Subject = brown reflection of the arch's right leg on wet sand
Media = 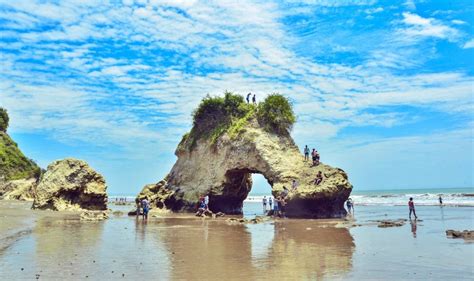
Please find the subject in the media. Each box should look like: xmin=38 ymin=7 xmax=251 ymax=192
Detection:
xmin=265 ymin=220 xmax=355 ymax=280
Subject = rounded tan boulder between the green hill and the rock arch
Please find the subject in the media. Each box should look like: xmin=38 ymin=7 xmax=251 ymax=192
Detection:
xmin=33 ymin=159 xmax=107 ymax=211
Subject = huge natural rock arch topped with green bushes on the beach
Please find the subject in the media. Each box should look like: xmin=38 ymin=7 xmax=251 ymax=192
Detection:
xmin=138 ymin=95 xmax=352 ymax=218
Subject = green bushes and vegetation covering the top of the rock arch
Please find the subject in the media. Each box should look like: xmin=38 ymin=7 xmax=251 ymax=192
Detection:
xmin=178 ymin=92 xmax=296 ymax=151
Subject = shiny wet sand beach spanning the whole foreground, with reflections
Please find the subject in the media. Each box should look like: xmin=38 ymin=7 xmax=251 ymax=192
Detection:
xmin=0 ymin=201 xmax=474 ymax=280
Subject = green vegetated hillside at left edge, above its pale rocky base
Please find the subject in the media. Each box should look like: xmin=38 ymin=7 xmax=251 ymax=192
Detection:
xmin=0 ymin=108 xmax=41 ymax=180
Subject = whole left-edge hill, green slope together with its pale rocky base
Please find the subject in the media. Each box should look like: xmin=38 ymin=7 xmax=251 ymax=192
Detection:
xmin=0 ymin=107 xmax=41 ymax=200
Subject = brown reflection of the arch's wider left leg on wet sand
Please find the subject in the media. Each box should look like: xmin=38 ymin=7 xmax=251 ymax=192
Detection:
xmin=159 ymin=219 xmax=253 ymax=280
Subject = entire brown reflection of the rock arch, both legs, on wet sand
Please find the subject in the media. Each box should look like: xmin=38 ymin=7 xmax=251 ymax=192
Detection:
xmin=159 ymin=220 xmax=355 ymax=280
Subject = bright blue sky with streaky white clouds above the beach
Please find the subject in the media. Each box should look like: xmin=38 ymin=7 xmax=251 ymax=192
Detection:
xmin=0 ymin=0 xmax=474 ymax=194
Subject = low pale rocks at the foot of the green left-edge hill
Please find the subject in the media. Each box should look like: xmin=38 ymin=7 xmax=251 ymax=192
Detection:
xmin=0 ymin=178 xmax=37 ymax=201
